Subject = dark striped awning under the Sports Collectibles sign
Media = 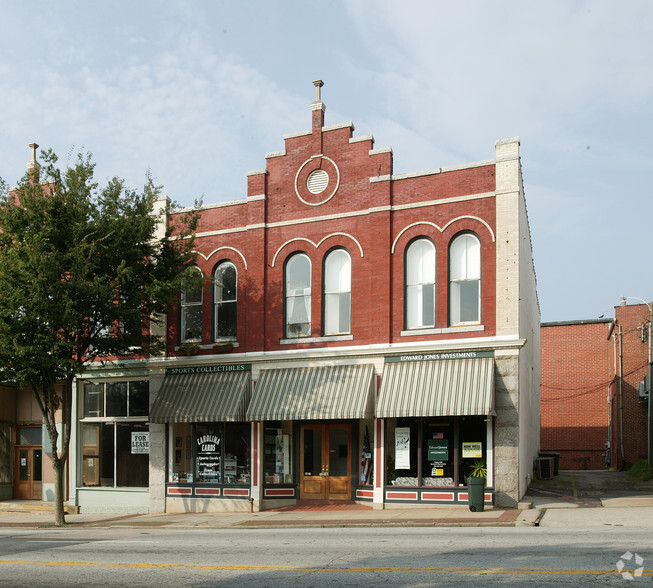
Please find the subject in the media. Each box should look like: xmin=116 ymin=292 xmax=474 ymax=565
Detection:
xmin=150 ymin=371 xmax=251 ymax=423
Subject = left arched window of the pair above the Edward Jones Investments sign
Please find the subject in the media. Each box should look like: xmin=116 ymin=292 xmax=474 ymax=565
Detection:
xmin=405 ymin=238 xmax=436 ymax=329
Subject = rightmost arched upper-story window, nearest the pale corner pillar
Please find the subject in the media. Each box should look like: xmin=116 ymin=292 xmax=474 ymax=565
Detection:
xmin=449 ymin=233 xmax=481 ymax=325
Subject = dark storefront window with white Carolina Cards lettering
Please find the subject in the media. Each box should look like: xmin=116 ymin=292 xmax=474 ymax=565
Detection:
xmin=170 ymin=423 xmax=251 ymax=484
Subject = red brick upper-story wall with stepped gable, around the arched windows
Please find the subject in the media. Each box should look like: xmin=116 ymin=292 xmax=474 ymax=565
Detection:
xmin=168 ymin=108 xmax=502 ymax=354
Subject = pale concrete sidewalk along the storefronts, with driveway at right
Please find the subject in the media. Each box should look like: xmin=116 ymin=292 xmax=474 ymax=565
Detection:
xmin=0 ymin=471 xmax=653 ymax=529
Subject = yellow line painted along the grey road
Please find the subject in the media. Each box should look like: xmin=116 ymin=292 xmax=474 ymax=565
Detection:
xmin=0 ymin=559 xmax=653 ymax=576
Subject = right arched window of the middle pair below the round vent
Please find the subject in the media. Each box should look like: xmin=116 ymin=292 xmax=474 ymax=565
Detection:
xmin=324 ymin=249 xmax=351 ymax=335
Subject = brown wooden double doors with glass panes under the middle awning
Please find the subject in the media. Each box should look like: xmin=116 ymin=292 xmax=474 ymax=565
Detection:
xmin=299 ymin=424 xmax=351 ymax=500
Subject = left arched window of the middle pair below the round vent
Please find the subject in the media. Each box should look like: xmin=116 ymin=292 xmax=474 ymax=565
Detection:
xmin=285 ymin=253 xmax=311 ymax=338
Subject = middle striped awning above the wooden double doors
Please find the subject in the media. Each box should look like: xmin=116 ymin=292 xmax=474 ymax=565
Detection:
xmin=247 ymin=364 xmax=376 ymax=421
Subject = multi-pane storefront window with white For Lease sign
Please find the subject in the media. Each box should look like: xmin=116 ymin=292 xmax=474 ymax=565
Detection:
xmin=80 ymin=380 xmax=149 ymax=488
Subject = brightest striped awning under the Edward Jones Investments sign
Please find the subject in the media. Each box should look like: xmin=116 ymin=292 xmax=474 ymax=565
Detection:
xmin=376 ymin=357 xmax=494 ymax=418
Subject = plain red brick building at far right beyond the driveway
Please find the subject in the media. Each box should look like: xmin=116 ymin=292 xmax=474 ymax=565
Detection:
xmin=541 ymin=301 xmax=650 ymax=470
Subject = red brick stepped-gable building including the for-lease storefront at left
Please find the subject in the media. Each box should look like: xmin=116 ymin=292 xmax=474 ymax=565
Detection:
xmin=61 ymin=83 xmax=540 ymax=512
